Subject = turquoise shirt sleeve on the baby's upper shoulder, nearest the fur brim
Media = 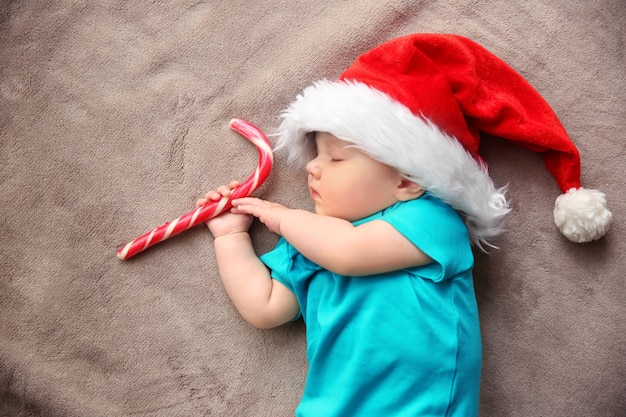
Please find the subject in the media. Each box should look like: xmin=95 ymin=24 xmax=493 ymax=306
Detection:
xmin=380 ymin=194 xmax=474 ymax=281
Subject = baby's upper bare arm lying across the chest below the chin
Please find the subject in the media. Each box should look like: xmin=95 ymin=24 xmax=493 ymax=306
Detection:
xmin=233 ymin=198 xmax=432 ymax=276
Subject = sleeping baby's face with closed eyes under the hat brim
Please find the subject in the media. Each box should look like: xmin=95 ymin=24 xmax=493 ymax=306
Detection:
xmin=306 ymin=132 xmax=404 ymax=221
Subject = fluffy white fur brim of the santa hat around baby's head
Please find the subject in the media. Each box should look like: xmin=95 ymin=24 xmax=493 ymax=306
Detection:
xmin=276 ymin=80 xmax=510 ymax=249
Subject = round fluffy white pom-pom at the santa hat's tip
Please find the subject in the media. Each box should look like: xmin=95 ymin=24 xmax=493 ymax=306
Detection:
xmin=554 ymin=188 xmax=613 ymax=243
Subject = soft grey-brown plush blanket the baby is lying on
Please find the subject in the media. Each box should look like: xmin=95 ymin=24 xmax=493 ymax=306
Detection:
xmin=0 ymin=0 xmax=626 ymax=417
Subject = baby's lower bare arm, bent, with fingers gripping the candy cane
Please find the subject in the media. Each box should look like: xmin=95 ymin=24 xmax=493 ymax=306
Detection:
xmin=198 ymin=183 xmax=299 ymax=329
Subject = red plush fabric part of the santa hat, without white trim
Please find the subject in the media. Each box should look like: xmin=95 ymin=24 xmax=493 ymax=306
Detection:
xmin=340 ymin=34 xmax=580 ymax=192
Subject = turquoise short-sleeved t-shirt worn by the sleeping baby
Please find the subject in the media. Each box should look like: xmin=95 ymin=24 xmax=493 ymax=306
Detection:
xmin=261 ymin=195 xmax=481 ymax=417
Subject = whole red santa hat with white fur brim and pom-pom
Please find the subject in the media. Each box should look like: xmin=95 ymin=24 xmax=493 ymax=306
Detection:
xmin=277 ymin=34 xmax=612 ymax=248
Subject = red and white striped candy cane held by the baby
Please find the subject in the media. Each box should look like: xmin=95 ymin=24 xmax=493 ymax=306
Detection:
xmin=117 ymin=119 xmax=274 ymax=259
